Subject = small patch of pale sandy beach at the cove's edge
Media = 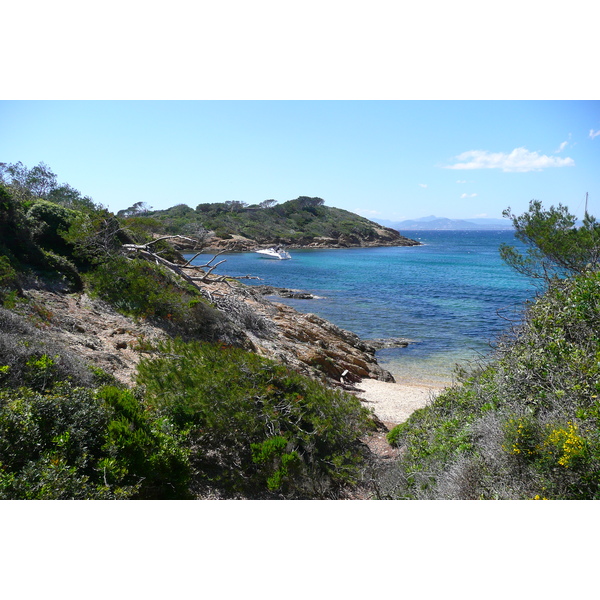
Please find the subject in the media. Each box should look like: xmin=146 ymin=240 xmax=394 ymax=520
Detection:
xmin=356 ymin=379 xmax=441 ymax=424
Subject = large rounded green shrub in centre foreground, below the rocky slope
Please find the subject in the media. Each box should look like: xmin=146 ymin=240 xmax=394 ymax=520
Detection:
xmin=138 ymin=341 xmax=372 ymax=498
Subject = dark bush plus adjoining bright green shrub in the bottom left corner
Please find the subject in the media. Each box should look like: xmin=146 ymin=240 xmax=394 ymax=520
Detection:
xmin=0 ymin=386 xmax=190 ymax=500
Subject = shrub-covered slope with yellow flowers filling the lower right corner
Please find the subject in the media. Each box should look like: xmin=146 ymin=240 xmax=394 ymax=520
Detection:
xmin=389 ymin=272 xmax=600 ymax=499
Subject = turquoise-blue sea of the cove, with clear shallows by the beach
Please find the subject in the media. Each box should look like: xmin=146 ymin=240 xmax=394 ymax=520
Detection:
xmin=186 ymin=230 xmax=536 ymax=387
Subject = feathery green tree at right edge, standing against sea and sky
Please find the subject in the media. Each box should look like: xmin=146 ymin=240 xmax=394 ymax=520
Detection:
xmin=500 ymin=200 xmax=600 ymax=283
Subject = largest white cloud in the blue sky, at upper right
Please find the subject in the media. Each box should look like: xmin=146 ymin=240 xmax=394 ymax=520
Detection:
xmin=446 ymin=148 xmax=575 ymax=173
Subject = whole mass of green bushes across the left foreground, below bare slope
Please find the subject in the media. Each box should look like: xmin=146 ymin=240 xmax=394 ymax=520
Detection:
xmin=0 ymin=309 xmax=372 ymax=499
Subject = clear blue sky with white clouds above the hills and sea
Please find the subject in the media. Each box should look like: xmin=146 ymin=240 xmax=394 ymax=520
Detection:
xmin=0 ymin=100 xmax=600 ymax=221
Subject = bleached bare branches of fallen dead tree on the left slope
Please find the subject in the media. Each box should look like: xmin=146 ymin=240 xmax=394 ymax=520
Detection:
xmin=122 ymin=235 xmax=259 ymax=286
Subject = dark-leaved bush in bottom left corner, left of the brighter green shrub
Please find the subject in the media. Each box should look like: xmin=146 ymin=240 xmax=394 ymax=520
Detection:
xmin=0 ymin=389 xmax=120 ymax=499
